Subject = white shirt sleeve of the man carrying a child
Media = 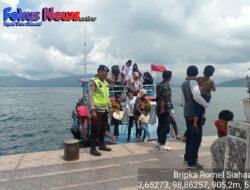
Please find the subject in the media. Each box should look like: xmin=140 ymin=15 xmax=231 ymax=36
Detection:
xmin=182 ymin=80 xmax=208 ymax=108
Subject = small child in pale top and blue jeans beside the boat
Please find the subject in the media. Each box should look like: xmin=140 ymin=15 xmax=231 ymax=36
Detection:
xmin=137 ymin=106 xmax=150 ymax=142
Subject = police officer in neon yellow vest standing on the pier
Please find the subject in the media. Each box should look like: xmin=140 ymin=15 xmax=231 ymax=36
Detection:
xmin=89 ymin=65 xmax=111 ymax=156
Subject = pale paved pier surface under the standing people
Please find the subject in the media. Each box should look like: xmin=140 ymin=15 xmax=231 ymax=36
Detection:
xmin=0 ymin=136 xmax=217 ymax=190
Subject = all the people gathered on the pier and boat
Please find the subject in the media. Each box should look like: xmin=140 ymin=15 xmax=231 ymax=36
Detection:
xmin=74 ymin=60 xmax=233 ymax=168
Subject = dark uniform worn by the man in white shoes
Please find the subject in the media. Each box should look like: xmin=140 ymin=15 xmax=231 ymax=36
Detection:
xmin=156 ymin=81 xmax=173 ymax=145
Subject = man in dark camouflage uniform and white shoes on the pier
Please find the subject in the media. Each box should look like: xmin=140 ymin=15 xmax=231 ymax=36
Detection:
xmin=156 ymin=71 xmax=174 ymax=150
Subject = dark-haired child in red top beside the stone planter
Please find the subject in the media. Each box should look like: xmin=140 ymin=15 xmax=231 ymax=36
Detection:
xmin=214 ymin=110 xmax=234 ymax=138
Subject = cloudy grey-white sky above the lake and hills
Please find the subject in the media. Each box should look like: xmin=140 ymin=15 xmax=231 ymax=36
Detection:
xmin=0 ymin=0 xmax=250 ymax=81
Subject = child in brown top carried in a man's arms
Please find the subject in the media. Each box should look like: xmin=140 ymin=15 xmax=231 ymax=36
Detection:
xmin=194 ymin=65 xmax=215 ymax=128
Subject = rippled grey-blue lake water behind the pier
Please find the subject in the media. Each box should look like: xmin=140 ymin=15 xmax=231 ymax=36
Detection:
xmin=0 ymin=87 xmax=247 ymax=155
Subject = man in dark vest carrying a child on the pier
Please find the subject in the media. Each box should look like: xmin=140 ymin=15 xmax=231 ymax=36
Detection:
xmin=181 ymin=65 xmax=208 ymax=169
